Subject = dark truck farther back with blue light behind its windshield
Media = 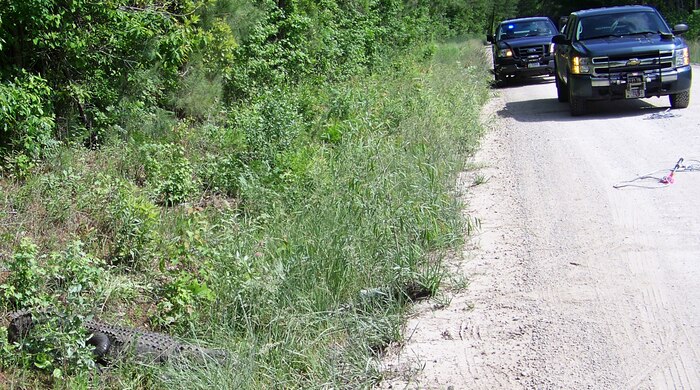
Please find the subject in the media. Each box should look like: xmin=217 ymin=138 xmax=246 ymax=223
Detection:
xmin=486 ymin=17 xmax=558 ymax=83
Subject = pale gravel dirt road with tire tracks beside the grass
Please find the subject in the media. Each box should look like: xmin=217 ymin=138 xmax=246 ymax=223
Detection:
xmin=382 ymin=67 xmax=700 ymax=389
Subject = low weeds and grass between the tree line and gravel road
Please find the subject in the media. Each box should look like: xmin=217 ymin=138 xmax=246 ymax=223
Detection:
xmin=0 ymin=41 xmax=488 ymax=388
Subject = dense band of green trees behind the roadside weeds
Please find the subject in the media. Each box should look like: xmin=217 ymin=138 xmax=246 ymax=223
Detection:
xmin=0 ymin=0 xmax=501 ymax=165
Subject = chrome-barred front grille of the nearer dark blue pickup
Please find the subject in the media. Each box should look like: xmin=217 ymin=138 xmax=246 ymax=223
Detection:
xmin=592 ymin=51 xmax=673 ymax=75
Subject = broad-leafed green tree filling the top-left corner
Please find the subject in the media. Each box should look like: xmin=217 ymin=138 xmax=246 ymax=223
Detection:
xmin=0 ymin=0 xmax=202 ymax=150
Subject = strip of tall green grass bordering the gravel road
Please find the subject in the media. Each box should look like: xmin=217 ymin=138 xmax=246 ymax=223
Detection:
xmin=169 ymin=41 xmax=487 ymax=388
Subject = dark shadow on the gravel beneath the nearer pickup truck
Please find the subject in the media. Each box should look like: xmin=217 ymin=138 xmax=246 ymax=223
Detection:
xmin=497 ymin=93 xmax=668 ymax=122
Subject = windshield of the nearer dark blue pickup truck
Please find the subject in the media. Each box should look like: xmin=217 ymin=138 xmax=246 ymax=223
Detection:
xmin=576 ymin=11 xmax=670 ymax=40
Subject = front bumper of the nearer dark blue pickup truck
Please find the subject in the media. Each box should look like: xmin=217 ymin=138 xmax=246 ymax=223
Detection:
xmin=569 ymin=66 xmax=692 ymax=100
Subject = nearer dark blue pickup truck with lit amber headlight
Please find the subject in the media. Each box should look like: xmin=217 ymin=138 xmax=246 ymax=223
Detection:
xmin=552 ymin=6 xmax=692 ymax=115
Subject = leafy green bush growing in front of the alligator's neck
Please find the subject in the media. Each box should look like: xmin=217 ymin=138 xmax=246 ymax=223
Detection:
xmin=0 ymin=240 xmax=104 ymax=378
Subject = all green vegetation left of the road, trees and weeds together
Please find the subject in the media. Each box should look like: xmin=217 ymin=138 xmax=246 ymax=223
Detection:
xmin=0 ymin=0 xmax=489 ymax=389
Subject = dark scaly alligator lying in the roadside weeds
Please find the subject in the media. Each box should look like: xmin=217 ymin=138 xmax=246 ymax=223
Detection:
xmin=7 ymin=310 xmax=228 ymax=362
